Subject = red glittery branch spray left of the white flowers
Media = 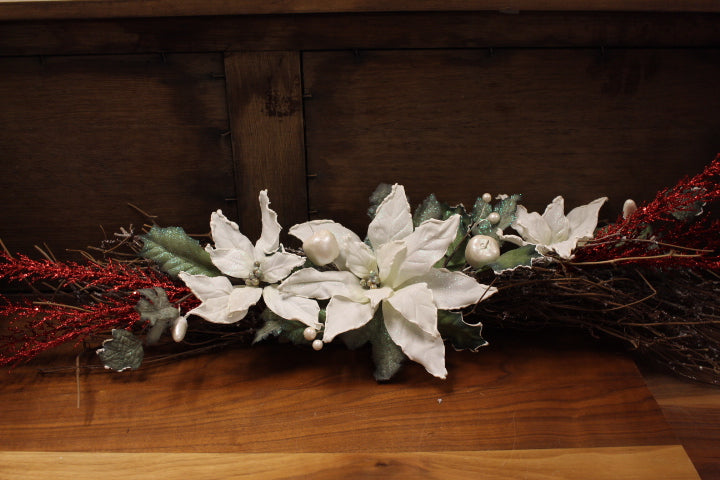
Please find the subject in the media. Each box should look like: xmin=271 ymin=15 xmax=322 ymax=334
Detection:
xmin=0 ymin=254 xmax=197 ymax=365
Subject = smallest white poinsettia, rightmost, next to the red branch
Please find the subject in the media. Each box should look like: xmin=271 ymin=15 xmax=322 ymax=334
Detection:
xmin=502 ymin=196 xmax=607 ymax=259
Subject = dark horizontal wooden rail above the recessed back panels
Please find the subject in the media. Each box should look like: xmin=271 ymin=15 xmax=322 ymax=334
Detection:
xmin=0 ymin=12 xmax=720 ymax=55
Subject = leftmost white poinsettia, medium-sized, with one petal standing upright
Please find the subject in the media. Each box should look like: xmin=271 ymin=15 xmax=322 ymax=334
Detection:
xmin=180 ymin=190 xmax=320 ymax=329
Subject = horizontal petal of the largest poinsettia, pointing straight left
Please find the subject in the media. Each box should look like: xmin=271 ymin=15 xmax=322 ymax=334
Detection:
xmin=278 ymin=268 xmax=365 ymax=300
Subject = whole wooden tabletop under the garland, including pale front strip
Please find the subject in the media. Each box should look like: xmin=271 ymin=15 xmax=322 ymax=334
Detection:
xmin=0 ymin=336 xmax=718 ymax=479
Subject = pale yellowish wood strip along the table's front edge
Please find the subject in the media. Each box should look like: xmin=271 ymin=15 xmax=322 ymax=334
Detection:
xmin=0 ymin=445 xmax=699 ymax=480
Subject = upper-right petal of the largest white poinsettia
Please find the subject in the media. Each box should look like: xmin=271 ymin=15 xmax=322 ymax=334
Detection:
xmin=391 ymin=215 xmax=460 ymax=287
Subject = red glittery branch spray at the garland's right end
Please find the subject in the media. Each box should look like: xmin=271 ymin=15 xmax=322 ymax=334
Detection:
xmin=574 ymin=155 xmax=720 ymax=271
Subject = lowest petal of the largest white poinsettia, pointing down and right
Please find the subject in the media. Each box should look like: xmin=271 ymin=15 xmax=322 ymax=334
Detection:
xmin=382 ymin=302 xmax=447 ymax=378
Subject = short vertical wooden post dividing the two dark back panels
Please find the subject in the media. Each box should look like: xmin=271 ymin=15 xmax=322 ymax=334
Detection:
xmin=225 ymin=52 xmax=307 ymax=244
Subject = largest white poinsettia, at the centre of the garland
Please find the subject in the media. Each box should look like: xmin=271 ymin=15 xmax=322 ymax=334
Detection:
xmin=279 ymin=185 xmax=497 ymax=378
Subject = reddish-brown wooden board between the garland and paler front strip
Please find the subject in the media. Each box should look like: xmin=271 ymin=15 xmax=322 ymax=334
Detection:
xmin=0 ymin=335 xmax=675 ymax=454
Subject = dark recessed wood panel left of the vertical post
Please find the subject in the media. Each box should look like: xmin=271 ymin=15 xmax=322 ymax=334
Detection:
xmin=0 ymin=54 xmax=236 ymax=256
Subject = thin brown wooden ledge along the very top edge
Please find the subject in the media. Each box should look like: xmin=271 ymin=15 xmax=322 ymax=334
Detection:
xmin=0 ymin=0 xmax=720 ymax=20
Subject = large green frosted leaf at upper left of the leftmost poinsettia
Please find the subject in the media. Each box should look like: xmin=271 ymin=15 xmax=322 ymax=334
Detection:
xmin=140 ymin=226 xmax=222 ymax=278
